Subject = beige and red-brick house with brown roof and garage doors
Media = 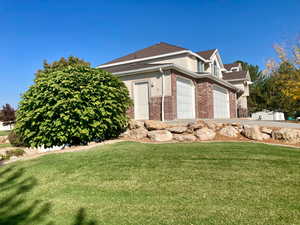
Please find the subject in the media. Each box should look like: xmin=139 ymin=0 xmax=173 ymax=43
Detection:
xmin=98 ymin=42 xmax=249 ymax=121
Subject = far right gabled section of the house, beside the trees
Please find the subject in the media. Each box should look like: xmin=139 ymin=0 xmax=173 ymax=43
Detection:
xmin=222 ymin=63 xmax=252 ymax=117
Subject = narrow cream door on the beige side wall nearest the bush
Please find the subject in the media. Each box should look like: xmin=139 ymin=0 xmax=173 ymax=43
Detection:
xmin=134 ymin=82 xmax=149 ymax=120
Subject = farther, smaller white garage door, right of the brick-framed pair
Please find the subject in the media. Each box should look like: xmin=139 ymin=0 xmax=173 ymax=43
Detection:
xmin=213 ymin=86 xmax=229 ymax=119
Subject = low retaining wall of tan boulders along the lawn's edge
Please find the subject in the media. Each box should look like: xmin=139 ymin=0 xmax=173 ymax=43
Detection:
xmin=121 ymin=120 xmax=300 ymax=144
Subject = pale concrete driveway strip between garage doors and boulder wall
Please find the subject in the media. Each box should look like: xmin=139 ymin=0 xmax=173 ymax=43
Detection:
xmin=168 ymin=119 xmax=300 ymax=129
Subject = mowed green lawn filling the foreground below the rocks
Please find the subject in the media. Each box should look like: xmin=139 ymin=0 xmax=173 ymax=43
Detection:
xmin=0 ymin=142 xmax=300 ymax=225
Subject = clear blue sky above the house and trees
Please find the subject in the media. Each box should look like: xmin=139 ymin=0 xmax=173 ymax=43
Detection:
xmin=0 ymin=0 xmax=300 ymax=106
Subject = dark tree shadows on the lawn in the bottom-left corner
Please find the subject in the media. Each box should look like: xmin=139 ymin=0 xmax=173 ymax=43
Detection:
xmin=0 ymin=167 xmax=97 ymax=225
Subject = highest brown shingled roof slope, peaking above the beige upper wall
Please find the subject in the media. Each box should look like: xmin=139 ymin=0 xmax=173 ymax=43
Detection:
xmin=102 ymin=42 xmax=187 ymax=65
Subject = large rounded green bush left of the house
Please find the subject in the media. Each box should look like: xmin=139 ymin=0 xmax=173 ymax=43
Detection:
xmin=14 ymin=57 xmax=131 ymax=147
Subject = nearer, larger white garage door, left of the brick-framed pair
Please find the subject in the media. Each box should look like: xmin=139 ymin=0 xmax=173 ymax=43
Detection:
xmin=176 ymin=78 xmax=195 ymax=119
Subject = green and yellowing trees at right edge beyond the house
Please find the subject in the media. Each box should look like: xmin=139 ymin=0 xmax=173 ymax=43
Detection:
xmin=239 ymin=40 xmax=300 ymax=116
